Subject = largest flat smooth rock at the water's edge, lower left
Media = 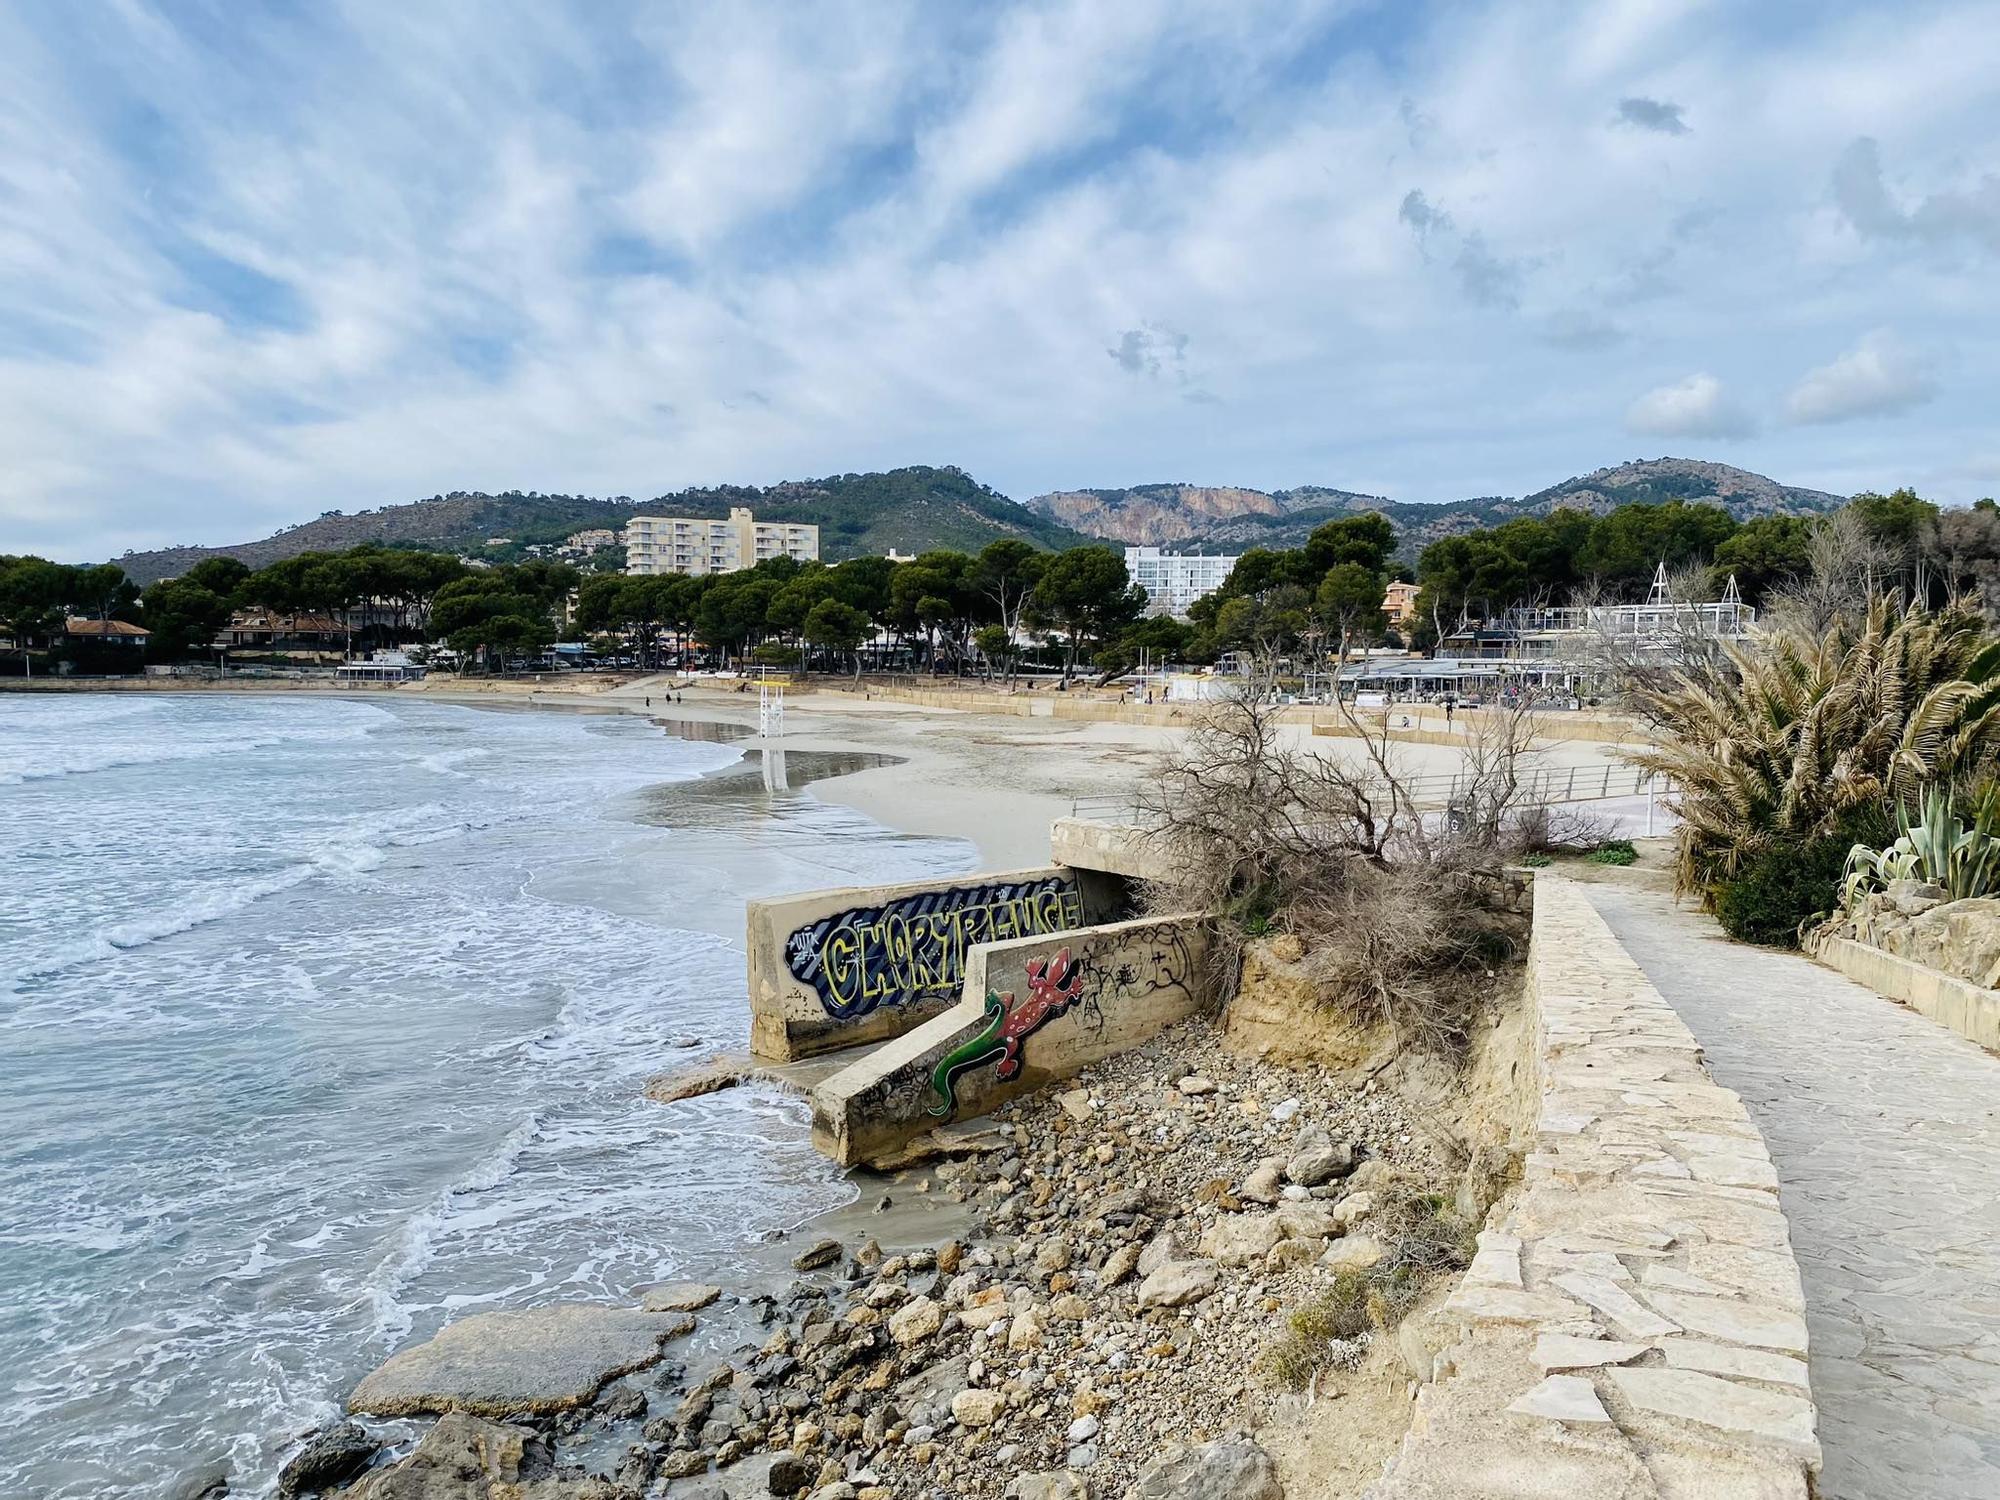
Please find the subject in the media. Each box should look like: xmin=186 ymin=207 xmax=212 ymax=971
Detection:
xmin=348 ymin=1306 xmax=694 ymax=1416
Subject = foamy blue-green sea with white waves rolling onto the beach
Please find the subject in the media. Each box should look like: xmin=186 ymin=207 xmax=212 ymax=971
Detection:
xmin=0 ymin=694 xmax=972 ymax=1498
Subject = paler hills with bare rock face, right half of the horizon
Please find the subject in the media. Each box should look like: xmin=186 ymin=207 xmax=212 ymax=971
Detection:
xmin=1028 ymin=458 xmax=1844 ymax=558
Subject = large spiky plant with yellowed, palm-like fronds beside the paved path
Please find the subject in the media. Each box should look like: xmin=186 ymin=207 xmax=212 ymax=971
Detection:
xmin=1632 ymin=596 xmax=2000 ymax=904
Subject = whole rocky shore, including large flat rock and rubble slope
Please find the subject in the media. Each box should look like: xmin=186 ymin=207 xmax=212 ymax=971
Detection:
xmin=300 ymin=1020 xmax=1484 ymax=1500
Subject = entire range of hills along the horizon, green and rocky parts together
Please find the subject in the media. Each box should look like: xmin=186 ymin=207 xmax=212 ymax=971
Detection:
xmin=118 ymin=458 xmax=1846 ymax=584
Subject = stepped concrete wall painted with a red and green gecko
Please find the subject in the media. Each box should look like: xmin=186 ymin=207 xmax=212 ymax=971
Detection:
xmin=812 ymin=916 xmax=1210 ymax=1166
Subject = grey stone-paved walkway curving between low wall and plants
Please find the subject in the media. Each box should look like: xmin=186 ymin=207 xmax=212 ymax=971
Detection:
xmin=1584 ymin=884 xmax=2000 ymax=1500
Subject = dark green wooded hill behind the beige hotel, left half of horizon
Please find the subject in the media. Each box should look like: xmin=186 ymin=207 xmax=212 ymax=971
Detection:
xmin=118 ymin=468 xmax=1088 ymax=584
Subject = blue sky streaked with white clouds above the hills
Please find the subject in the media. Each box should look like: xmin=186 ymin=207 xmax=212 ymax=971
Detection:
xmin=0 ymin=0 xmax=2000 ymax=560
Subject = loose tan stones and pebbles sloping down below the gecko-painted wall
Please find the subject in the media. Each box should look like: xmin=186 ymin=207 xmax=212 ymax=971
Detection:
xmin=532 ymin=1022 xmax=1430 ymax=1500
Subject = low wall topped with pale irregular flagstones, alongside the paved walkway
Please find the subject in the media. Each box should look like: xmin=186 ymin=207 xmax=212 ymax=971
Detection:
xmin=1368 ymin=878 xmax=1820 ymax=1500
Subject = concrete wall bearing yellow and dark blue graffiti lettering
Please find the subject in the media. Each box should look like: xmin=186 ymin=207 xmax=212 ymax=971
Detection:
xmin=746 ymin=866 xmax=1124 ymax=1062
